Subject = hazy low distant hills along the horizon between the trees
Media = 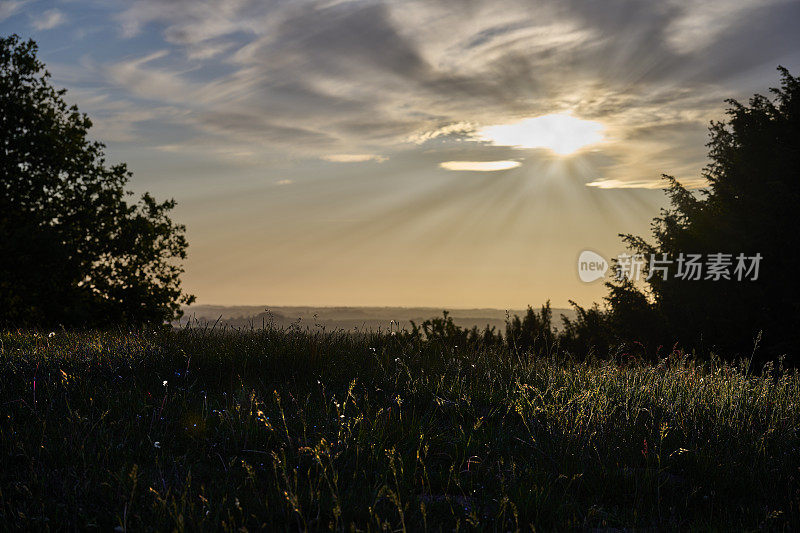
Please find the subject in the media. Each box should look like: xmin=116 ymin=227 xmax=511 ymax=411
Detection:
xmin=179 ymin=305 xmax=575 ymax=332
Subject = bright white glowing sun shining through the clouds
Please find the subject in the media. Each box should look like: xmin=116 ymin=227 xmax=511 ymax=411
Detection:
xmin=477 ymin=113 xmax=605 ymax=155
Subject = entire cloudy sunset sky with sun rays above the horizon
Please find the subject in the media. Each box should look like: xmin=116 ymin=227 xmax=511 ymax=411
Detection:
xmin=0 ymin=0 xmax=800 ymax=309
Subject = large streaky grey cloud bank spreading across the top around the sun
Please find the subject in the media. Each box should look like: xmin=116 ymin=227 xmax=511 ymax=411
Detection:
xmin=72 ymin=0 xmax=800 ymax=182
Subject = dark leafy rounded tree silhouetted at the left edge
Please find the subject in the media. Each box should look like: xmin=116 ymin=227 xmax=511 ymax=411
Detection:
xmin=0 ymin=35 xmax=194 ymax=326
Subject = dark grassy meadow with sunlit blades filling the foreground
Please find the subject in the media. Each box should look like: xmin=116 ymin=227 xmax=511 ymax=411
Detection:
xmin=0 ymin=330 xmax=800 ymax=531
